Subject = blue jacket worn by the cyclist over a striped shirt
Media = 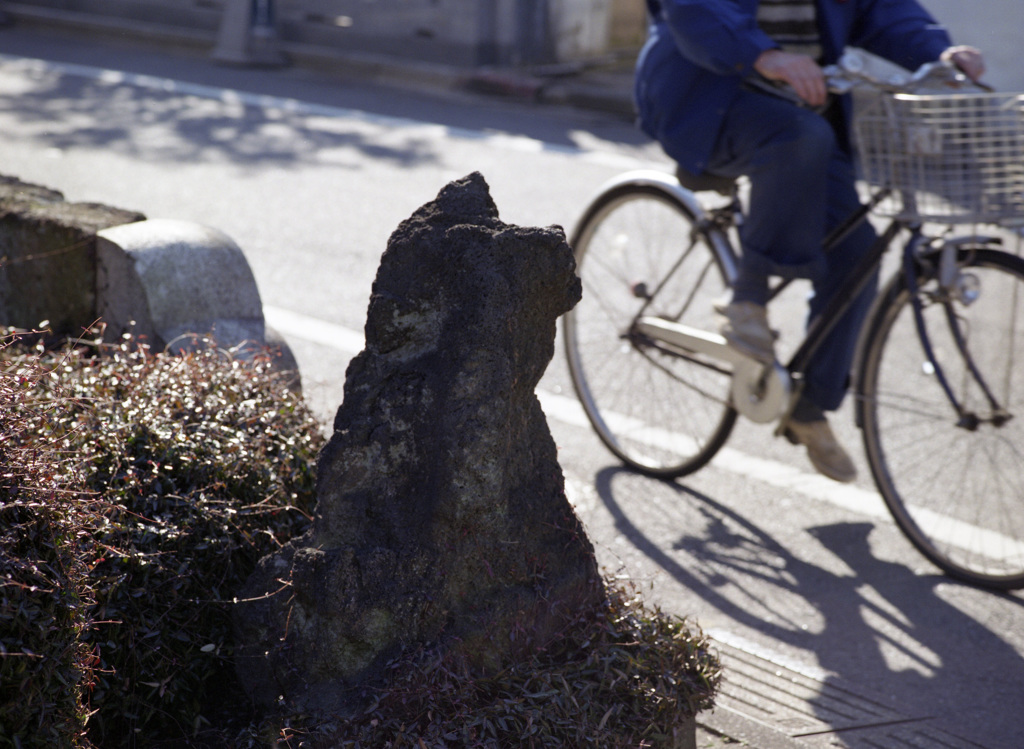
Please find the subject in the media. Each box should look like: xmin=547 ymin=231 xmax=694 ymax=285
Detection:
xmin=636 ymin=0 xmax=951 ymax=173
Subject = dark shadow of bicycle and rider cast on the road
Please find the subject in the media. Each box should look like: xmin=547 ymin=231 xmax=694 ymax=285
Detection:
xmin=595 ymin=467 xmax=1024 ymax=749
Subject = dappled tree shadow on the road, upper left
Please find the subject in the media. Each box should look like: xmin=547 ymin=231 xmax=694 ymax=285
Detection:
xmin=0 ymin=65 xmax=438 ymax=169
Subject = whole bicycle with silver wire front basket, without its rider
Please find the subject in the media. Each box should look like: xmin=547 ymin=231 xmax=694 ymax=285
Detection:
xmin=563 ymin=54 xmax=1024 ymax=589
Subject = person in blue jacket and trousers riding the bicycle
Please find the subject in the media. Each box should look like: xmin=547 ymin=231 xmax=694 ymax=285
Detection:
xmin=636 ymin=0 xmax=984 ymax=482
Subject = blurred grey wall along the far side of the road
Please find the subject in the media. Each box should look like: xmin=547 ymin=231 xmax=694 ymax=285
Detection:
xmin=0 ymin=0 xmax=1024 ymax=86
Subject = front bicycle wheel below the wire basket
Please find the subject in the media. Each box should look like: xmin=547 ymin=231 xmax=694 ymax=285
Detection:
xmin=858 ymin=249 xmax=1024 ymax=589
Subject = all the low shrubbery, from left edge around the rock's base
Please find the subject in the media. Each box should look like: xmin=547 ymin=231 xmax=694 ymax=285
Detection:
xmin=0 ymin=331 xmax=719 ymax=749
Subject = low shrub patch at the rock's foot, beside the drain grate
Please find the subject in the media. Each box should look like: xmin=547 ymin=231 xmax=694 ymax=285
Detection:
xmin=264 ymin=581 xmax=720 ymax=749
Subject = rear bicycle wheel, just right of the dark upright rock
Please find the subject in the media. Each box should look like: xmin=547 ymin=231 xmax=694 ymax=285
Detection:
xmin=563 ymin=178 xmax=736 ymax=477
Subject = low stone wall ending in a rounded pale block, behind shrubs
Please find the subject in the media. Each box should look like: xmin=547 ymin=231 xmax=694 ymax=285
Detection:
xmin=0 ymin=175 xmax=300 ymax=390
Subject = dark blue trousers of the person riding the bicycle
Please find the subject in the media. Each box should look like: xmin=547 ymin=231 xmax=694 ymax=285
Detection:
xmin=708 ymin=91 xmax=878 ymax=411
